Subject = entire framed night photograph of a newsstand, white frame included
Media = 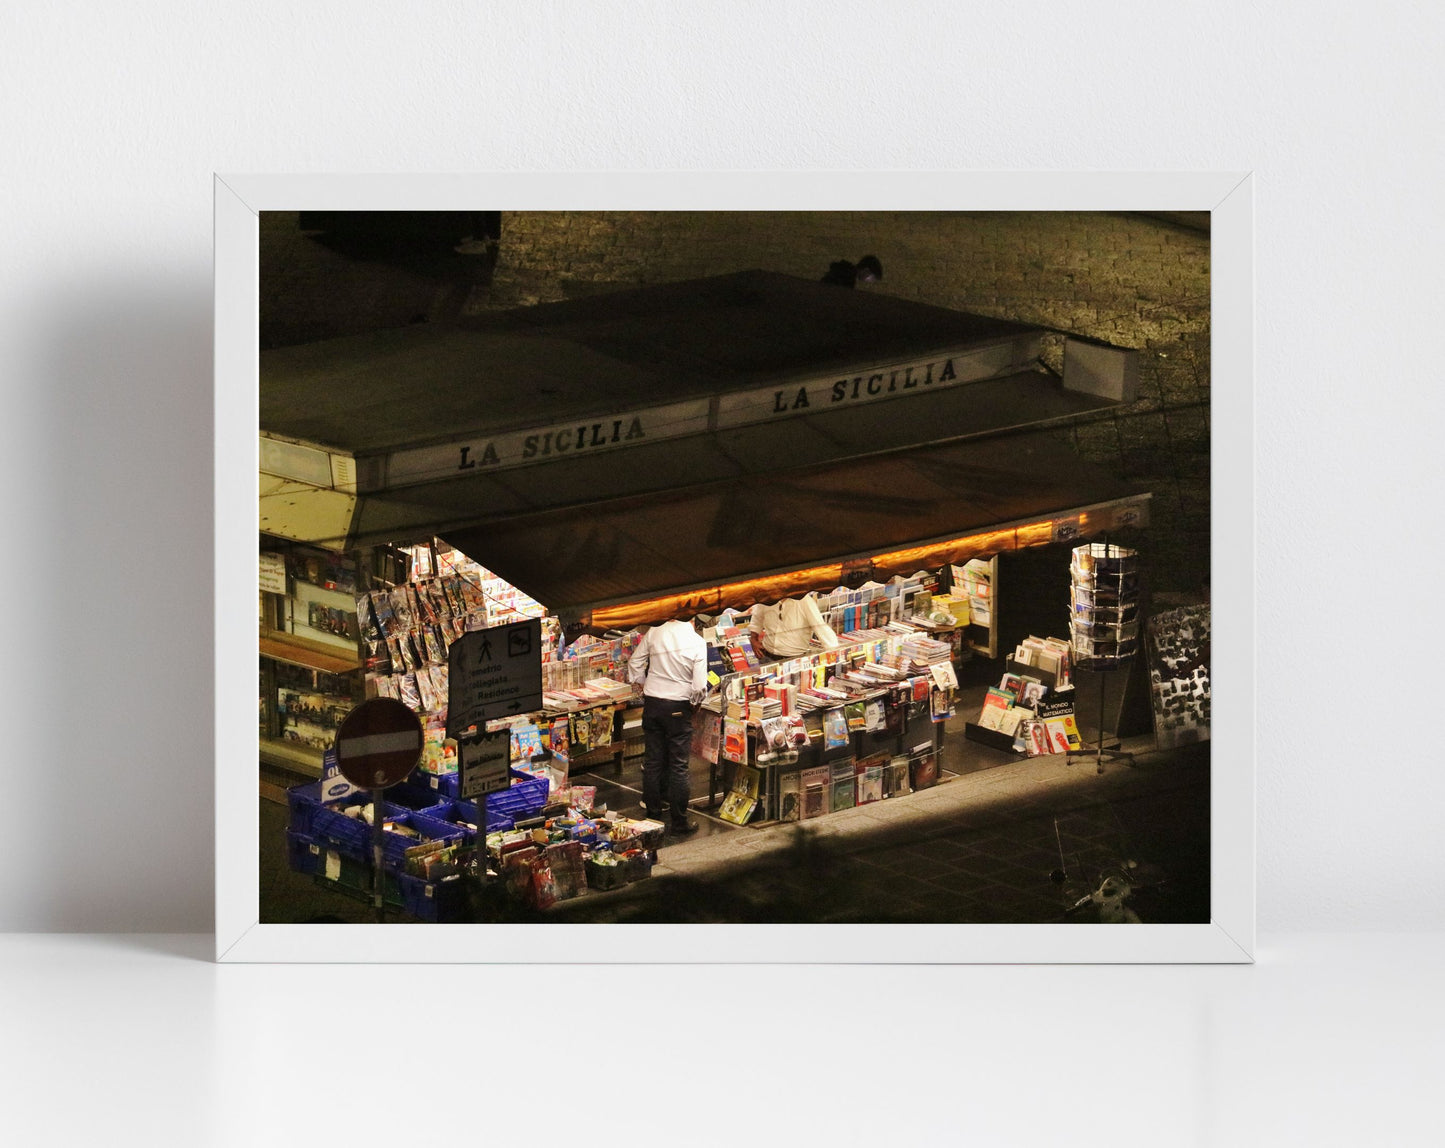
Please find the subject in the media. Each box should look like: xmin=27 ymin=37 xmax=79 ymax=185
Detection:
xmin=215 ymin=172 xmax=1254 ymax=963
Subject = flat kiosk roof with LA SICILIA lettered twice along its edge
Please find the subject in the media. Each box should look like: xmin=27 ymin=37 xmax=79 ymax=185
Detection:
xmin=259 ymin=272 xmax=1134 ymax=549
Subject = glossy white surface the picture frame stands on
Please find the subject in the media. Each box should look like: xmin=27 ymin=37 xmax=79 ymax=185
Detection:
xmin=0 ymin=934 xmax=1445 ymax=1148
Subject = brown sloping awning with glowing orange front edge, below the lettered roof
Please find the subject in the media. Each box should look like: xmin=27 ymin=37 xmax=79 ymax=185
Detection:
xmin=445 ymin=432 xmax=1149 ymax=626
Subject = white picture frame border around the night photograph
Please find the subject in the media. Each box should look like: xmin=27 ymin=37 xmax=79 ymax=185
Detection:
xmin=214 ymin=172 xmax=1256 ymax=963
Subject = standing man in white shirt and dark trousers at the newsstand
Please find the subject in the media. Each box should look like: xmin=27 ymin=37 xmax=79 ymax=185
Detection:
xmin=627 ymin=619 xmax=708 ymax=837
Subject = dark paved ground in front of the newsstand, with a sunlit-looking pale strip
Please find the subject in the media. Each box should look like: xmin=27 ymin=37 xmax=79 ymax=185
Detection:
xmin=551 ymin=737 xmax=1209 ymax=922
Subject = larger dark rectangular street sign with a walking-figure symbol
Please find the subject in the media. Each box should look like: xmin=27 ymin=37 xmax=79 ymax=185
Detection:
xmin=447 ymin=617 xmax=542 ymax=737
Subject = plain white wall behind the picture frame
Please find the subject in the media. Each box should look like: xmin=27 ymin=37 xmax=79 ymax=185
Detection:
xmin=0 ymin=0 xmax=1445 ymax=930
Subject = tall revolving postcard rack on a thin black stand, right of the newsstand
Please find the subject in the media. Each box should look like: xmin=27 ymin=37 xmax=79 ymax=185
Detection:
xmin=1069 ymin=538 xmax=1139 ymax=774
